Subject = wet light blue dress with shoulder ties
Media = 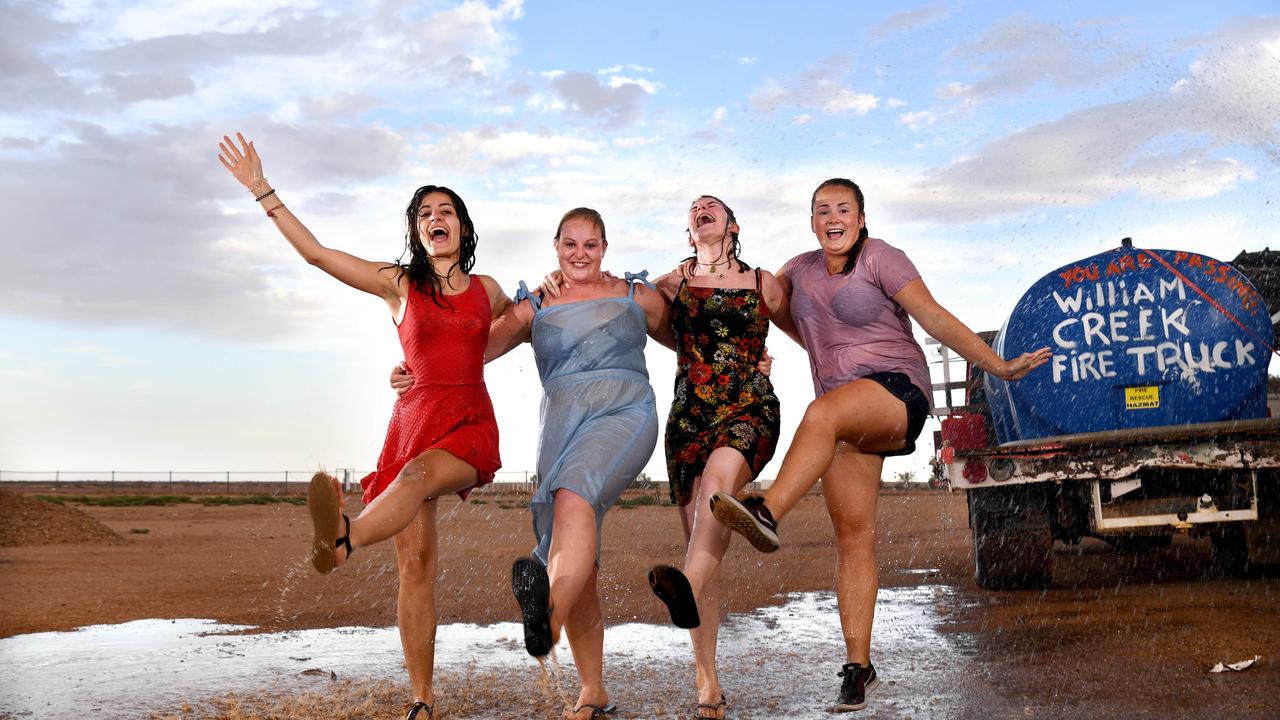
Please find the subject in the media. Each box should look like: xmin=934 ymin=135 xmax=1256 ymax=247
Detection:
xmin=516 ymin=273 xmax=658 ymax=565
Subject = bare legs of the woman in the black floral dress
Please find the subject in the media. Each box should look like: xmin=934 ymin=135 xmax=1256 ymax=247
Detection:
xmin=681 ymin=447 xmax=751 ymax=717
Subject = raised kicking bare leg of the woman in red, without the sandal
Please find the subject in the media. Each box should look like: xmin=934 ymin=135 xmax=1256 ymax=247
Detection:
xmin=339 ymin=450 xmax=476 ymax=559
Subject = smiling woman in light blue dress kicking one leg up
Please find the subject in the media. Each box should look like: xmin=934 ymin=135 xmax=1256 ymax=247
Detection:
xmin=485 ymin=208 xmax=673 ymax=720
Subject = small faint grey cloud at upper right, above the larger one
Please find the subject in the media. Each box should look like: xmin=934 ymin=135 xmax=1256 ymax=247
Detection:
xmin=938 ymin=13 xmax=1143 ymax=101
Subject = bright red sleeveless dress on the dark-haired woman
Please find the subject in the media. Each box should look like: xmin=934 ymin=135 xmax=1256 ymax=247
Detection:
xmin=360 ymin=275 xmax=502 ymax=502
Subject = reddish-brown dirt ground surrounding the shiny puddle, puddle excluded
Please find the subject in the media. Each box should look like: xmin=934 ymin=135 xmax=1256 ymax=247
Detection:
xmin=0 ymin=484 xmax=1280 ymax=720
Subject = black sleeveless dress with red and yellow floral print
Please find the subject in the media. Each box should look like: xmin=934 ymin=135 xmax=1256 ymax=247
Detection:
xmin=666 ymin=270 xmax=778 ymax=505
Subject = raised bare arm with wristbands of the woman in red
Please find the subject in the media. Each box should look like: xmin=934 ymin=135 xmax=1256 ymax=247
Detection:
xmin=218 ymin=133 xmax=401 ymax=301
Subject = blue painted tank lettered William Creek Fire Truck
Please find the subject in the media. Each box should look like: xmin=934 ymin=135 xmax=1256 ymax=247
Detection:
xmin=987 ymin=247 xmax=1276 ymax=443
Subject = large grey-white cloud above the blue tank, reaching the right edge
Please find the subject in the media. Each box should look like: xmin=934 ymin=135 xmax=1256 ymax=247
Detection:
xmin=902 ymin=22 xmax=1280 ymax=222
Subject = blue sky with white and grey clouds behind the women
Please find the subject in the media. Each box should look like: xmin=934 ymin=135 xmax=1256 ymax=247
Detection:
xmin=0 ymin=0 xmax=1280 ymax=479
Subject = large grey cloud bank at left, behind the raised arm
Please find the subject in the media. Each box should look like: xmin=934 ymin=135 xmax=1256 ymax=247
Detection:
xmin=0 ymin=122 xmax=404 ymax=340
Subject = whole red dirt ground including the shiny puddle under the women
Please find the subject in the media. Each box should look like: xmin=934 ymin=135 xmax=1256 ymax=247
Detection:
xmin=0 ymin=484 xmax=1280 ymax=720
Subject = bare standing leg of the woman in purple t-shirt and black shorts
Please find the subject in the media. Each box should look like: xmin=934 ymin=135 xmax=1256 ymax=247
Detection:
xmin=822 ymin=445 xmax=884 ymax=665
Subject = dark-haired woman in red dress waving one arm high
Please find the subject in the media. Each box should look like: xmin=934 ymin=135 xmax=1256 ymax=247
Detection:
xmin=219 ymin=135 xmax=501 ymax=720
